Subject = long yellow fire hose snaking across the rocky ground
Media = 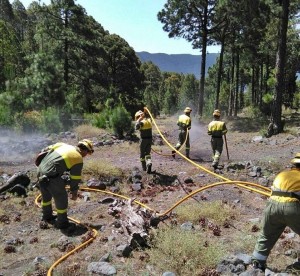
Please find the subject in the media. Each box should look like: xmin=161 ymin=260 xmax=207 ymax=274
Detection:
xmin=35 ymin=107 xmax=271 ymax=276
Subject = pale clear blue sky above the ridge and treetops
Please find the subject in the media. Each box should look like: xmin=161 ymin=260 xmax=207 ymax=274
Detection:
xmin=10 ymin=0 xmax=219 ymax=55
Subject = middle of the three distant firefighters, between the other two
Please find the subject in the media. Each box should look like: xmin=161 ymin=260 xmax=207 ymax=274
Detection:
xmin=172 ymin=107 xmax=192 ymax=158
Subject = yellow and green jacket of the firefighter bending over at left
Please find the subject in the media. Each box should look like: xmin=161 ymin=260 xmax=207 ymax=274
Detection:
xmin=38 ymin=143 xmax=83 ymax=191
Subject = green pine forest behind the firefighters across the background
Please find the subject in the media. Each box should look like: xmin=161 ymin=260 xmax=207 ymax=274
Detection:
xmin=0 ymin=0 xmax=300 ymax=134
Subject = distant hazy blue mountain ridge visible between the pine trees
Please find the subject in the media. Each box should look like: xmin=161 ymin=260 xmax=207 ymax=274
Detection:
xmin=136 ymin=52 xmax=219 ymax=79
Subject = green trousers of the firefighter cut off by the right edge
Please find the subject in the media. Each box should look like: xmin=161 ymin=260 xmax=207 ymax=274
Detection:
xmin=253 ymin=199 xmax=300 ymax=261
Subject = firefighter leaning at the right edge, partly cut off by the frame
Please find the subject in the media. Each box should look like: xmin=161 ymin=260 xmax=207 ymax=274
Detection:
xmin=252 ymin=153 xmax=300 ymax=275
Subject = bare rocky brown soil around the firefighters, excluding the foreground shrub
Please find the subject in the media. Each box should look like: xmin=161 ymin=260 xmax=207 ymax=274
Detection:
xmin=0 ymin=113 xmax=300 ymax=275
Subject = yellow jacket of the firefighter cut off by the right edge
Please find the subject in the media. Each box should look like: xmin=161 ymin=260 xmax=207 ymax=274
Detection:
xmin=270 ymin=168 xmax=300 ymax=202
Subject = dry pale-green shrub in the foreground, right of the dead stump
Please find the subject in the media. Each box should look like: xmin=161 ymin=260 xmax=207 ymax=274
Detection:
xmin=147 ymin=228 xmax=225 ymax=275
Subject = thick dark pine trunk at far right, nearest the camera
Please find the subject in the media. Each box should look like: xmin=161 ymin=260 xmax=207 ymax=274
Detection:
xmin=272 ymin=0 xmax=290 ymax=134
